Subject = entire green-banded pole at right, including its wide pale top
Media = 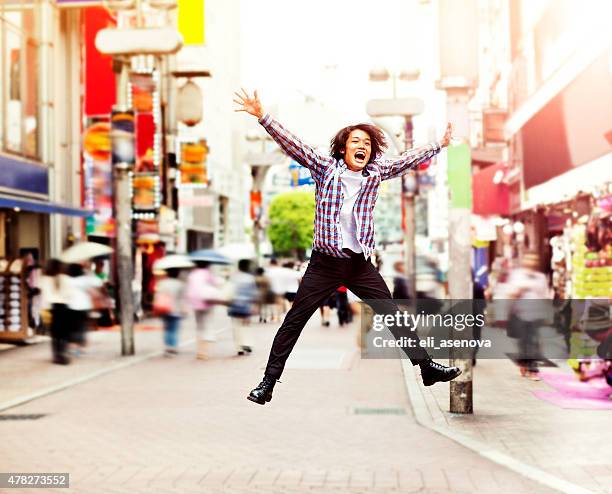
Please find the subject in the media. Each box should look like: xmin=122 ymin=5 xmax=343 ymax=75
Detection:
xmin=436 ymin=0 xmax=479 ymax=413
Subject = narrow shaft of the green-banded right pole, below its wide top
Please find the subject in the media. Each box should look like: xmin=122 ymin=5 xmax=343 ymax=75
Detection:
xmin=446 ymin=88 xmax=474 ymax=413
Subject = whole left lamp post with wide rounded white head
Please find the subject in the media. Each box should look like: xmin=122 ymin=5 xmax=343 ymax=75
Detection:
xmin=96 ymin=0 xmax=183 ymax=355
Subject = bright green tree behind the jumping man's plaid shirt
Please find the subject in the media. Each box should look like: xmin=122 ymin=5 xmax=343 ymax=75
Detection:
xmin=268 ymin=191 xmax=315 ymax=260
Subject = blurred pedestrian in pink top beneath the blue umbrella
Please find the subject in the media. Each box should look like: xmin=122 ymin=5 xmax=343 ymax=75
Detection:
xmin=187 ymin=261 xmax=222 ymax=360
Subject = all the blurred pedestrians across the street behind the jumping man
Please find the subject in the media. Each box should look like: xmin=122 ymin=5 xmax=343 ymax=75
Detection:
xmin=36 ymin=245 xmax=612 ymax=392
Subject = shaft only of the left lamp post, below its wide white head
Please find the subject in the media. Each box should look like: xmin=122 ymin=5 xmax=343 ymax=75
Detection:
xmin=114 ymin=60 xmax=134 ymax=355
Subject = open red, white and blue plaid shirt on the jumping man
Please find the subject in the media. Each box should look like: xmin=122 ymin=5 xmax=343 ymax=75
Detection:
xmin=259 ymin=114 xmax=440 ymax=258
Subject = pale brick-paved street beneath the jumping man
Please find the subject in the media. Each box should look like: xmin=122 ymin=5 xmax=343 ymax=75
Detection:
xmin=0 ymin=310 xmax=553 ymax=494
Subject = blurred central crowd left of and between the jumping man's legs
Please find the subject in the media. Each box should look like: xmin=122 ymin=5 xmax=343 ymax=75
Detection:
xmin=153 ymin=258 xmax=368 ymax=360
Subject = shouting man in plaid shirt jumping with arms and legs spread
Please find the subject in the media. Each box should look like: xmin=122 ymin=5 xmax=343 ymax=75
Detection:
xmin=234 ymin=90 xmax=461 ymax=405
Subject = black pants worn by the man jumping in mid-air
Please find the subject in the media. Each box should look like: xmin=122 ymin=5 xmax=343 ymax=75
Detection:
xmin=266 ymin=251 xmax=429 ymax=379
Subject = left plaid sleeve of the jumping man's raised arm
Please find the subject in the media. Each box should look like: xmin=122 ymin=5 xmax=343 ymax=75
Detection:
xmin=259 ymin=113 xmax=331 ymax=181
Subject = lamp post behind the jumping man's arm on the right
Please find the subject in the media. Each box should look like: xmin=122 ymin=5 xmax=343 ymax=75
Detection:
xmin=367 ymin=68 xmax=424 ymax=299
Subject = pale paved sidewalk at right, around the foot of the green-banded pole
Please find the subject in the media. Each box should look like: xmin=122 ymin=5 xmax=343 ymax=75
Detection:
xmin=405 ymin=359 xmax=612 ymax=493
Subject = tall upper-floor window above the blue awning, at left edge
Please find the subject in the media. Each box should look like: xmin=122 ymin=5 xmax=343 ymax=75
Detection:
xmin=0 ymin=0 xmax=39 ymax=159
